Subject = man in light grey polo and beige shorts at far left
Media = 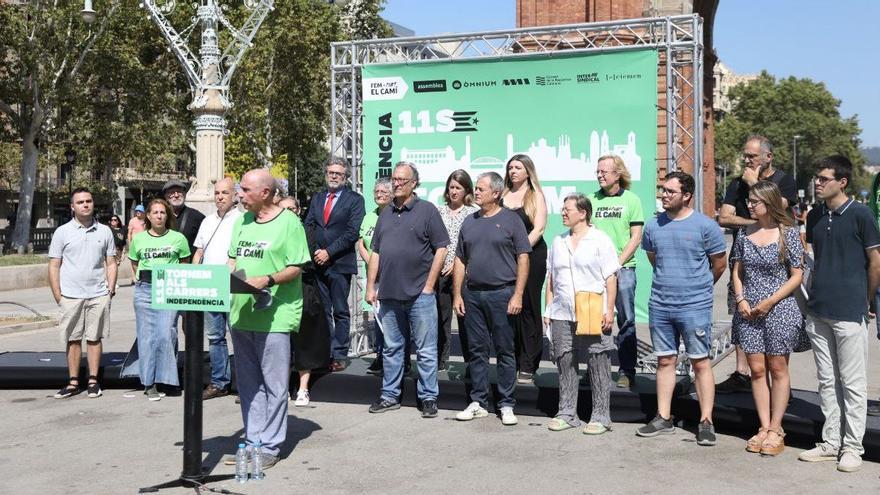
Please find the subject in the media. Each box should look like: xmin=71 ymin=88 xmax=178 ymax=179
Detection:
xmin=49 ymin=188 xmax=116 ymax=399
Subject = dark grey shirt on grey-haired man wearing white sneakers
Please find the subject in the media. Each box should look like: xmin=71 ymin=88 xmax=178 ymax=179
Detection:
xmin=455 ymin=208 xmax=532 ymax=286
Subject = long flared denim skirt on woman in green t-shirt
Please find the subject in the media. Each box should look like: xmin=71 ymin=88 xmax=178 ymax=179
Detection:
xmin=120 ymin=281 xmax=180 ymax=387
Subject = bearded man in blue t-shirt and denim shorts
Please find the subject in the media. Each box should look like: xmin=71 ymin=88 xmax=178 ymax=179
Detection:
xmin=636 ymin=172 xmax=727 ymax=446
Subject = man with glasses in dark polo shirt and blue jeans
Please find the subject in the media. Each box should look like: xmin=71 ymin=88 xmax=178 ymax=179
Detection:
xmin=364 ymin=162 xmax=449 ymax=418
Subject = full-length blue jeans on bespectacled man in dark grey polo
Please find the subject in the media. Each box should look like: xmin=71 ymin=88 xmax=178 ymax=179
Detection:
xmin=376 ymin=293 xmax=440 ymax=402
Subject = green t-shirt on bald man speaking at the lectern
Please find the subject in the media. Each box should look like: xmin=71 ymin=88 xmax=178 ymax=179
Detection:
xmin=229 ymin=210 xmax=311 ymax=333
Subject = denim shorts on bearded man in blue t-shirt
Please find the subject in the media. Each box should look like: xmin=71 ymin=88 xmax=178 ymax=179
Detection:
xmin=648 ymin=308 xmax=712 ymax=359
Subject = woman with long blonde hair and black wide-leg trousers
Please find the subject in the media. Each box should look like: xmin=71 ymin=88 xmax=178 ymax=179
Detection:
xmin=501 ymin=155 xmax=547 ymax=383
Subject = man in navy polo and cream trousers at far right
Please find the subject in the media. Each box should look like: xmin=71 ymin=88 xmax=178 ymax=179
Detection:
xmin=798 ymin=155 xmax=880 ymax=473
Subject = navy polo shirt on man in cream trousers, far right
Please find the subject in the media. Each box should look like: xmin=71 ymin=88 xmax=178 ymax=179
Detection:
xmin=807 ymin=199 xmax=880 ymax=322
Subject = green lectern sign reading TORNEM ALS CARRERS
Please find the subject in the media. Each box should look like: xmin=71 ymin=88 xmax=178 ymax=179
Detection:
xmin=152 ymin=264 xmax=229 ymax=313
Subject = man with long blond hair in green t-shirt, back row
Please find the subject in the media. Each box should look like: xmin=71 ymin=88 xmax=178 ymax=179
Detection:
xmin=589 ymin=155 xmax=645 ymax=388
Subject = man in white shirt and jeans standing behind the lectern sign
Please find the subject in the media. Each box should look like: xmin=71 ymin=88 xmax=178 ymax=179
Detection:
xmin=193 ymin=177 xmax=241 ymax=400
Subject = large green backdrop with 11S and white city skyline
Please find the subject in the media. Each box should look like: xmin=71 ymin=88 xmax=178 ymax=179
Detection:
xmin=362 ymin=50 xmax=657 ymax=321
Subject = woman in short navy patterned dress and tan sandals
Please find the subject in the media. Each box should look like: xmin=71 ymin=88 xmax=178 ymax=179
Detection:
xmin=731 ymin=180 xmax=808 ymax=456
